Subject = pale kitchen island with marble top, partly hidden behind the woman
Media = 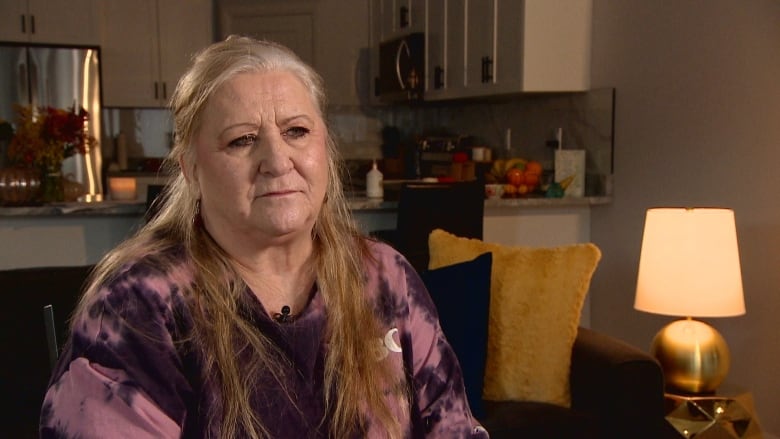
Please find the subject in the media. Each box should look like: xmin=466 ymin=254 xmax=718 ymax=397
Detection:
xmin=0 ymin=194 xmax=611 ymax=269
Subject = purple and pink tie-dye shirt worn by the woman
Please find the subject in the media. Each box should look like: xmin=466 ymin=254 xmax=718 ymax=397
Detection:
xmin=41 ymin=242 xmax=488 ymax=439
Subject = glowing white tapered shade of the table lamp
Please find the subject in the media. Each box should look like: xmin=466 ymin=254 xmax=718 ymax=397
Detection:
xmin=634 ymin=208 xmax=745 ymax=317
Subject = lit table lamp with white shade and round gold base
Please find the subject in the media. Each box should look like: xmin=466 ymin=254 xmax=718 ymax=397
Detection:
xmin=634 ymin=208 xmax=745 ymax=394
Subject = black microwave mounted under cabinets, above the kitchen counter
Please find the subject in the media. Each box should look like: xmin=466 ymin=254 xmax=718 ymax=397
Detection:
xmin=374 ymin=32 xmax=425 ymax=102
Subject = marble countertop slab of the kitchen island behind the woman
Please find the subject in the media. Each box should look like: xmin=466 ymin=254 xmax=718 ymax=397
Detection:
xmin=0 ymin=195 xmax=612 ymax=217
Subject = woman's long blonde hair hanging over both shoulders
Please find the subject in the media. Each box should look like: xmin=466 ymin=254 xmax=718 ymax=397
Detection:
xmin=81 ymin=36 xmax=408 ymax=438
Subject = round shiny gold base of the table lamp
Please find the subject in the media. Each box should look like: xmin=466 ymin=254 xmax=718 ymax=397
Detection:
xmin=651 ymin=318 xmax=731 ymax=395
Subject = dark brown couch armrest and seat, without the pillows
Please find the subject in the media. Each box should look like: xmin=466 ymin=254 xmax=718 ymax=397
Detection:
xmin=481 ymin=327 xmax=673 ymax=439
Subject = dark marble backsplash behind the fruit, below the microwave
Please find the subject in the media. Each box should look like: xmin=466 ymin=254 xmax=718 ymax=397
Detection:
xmin=377 ymin=88 xmax=615 ymax=180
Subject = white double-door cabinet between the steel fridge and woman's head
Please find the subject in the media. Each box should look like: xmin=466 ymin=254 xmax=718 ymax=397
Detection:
xmin=101 ymin=0 xmax=214 ymax=108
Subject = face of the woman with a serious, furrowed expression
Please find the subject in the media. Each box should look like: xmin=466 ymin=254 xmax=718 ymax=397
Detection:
xmin=189 ymin=71 xmax=328 ymax=251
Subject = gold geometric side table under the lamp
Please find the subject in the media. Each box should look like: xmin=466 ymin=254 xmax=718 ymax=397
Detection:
xmin=664 ymin=392 xmax=763 ymax=439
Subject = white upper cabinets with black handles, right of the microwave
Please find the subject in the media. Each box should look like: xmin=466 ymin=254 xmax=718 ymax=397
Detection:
xmin=425 ymin=0 xmax=592 ymax=100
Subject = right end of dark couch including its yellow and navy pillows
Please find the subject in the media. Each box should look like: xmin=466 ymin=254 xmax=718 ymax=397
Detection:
xmin=420 ymin=230 xmax=679 ymax=439
